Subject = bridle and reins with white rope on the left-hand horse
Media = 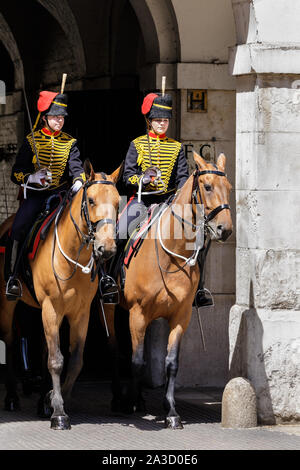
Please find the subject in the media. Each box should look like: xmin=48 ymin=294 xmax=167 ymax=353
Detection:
xmin=52 ymin=173 xmax=116 ymax=281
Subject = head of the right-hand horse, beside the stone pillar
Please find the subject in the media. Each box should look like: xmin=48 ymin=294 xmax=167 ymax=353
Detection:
xmin=194 ymin=152 xmax=232 ymax=241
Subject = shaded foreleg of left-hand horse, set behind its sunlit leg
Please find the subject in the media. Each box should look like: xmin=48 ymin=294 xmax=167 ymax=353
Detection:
xmin=62 ymin=312 xmax=89 ymax=399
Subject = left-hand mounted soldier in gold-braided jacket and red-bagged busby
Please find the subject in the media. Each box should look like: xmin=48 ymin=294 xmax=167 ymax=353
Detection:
xmin=6 ymin=91 xmax=86 ymax=300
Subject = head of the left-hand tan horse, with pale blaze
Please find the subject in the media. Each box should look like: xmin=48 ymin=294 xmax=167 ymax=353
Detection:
xmin=82 ymin=161 xmax=120 ymax=261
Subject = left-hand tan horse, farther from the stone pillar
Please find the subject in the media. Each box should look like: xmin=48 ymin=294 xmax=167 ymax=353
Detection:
xmin=0 ymin=162 xmax=120 ymax=430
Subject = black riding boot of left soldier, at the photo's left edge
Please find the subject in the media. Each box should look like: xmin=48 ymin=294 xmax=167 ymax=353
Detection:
xmin=5 ymin=240 xmax=22 ymax=300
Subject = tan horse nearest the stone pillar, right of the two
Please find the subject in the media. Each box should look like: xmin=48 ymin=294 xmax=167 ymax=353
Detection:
xmin=105 ymin=152 xmax=232 ymax=429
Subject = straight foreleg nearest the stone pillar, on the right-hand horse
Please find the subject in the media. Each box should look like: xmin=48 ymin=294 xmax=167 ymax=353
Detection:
xmin=164 ymin=319 xmax=188 ymax=429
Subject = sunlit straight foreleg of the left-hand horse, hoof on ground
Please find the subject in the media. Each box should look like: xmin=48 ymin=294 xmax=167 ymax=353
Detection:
xmin=42 ymin=298 xmax=71 ymax=429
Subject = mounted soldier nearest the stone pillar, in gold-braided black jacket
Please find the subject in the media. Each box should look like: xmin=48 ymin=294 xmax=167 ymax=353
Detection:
xmin=118 ymin=93 xmax=212 ymax=307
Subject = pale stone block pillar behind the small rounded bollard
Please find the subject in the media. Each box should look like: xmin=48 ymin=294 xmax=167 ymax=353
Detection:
xmin=229 ymin=0 xmax=300 ymax=424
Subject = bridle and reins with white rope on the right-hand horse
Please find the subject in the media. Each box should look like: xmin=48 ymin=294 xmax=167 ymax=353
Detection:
xmin=155 ymin=168 xmax=230 ymax=274
